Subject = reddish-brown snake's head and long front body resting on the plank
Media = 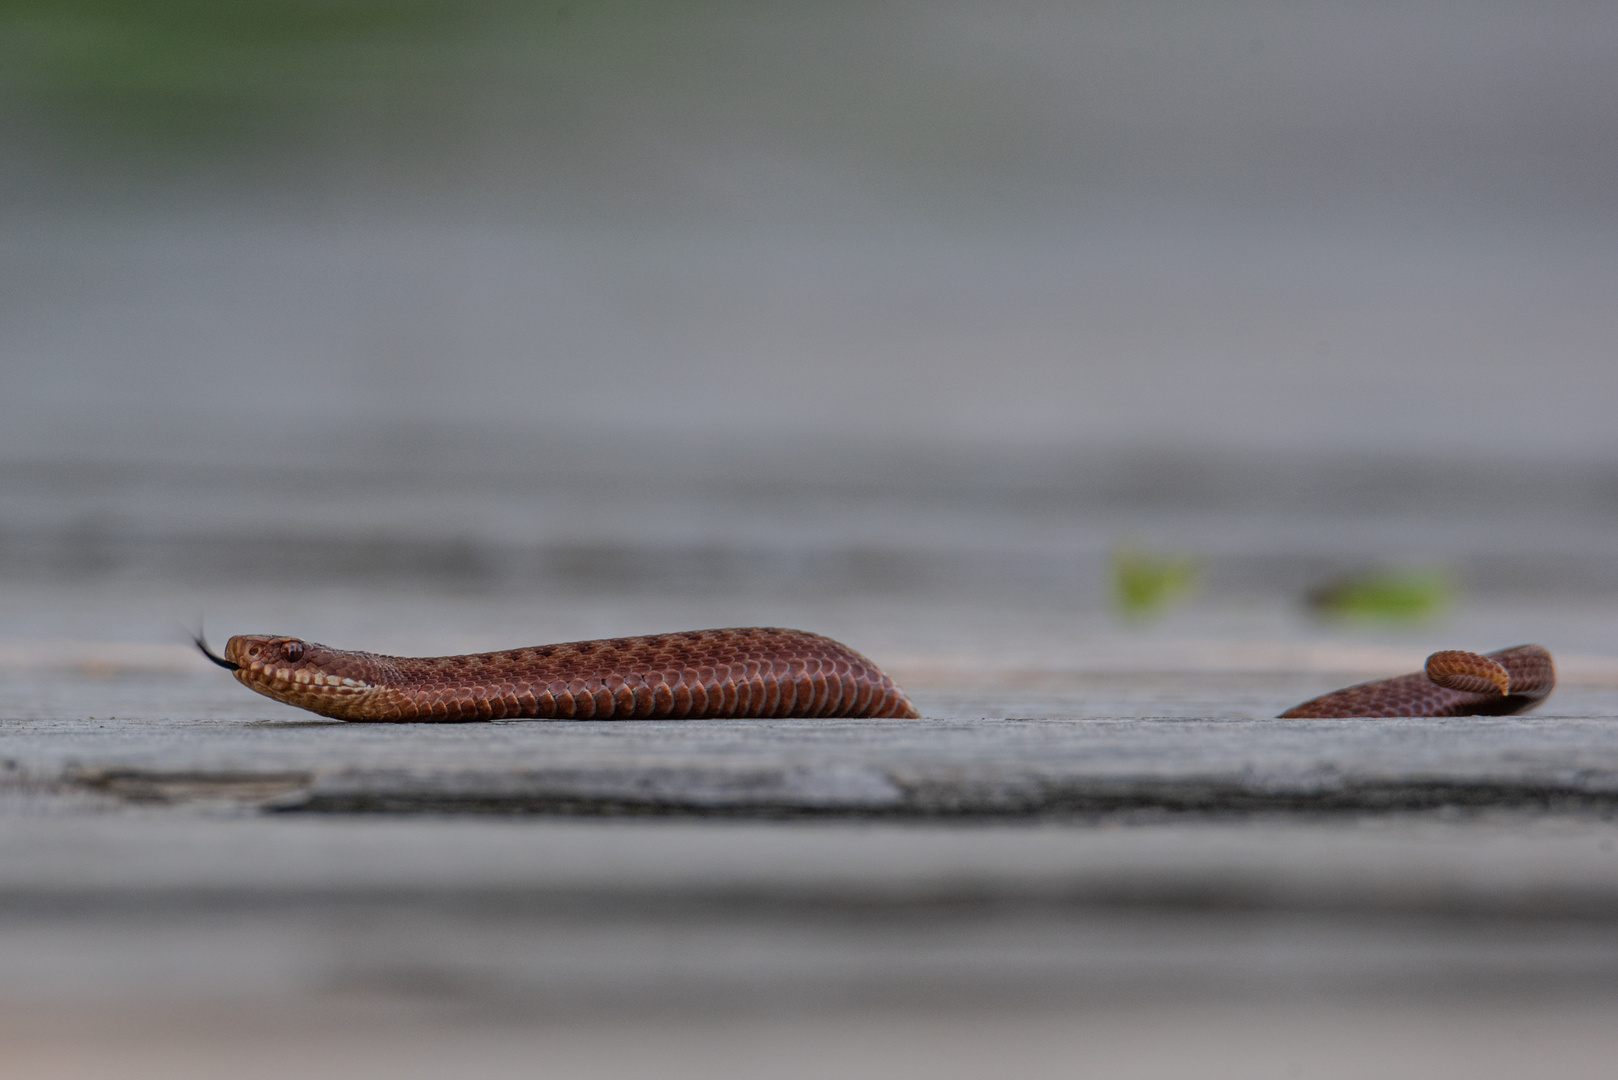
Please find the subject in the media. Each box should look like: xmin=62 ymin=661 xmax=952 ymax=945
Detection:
xmin=197 ymin=627 xmax=916 ymax=721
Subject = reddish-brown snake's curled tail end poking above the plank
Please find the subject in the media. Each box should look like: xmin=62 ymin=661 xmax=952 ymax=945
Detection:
xmin=1280 ymin=644 xmax=1557 ymax=719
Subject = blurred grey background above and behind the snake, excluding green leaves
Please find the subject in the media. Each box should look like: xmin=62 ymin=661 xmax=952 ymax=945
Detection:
xmin=0 ymin=0 xmax=1618 ymax=661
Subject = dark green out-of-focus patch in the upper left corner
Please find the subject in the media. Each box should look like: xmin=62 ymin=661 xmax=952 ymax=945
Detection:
xmin=0 ymin=0 xmax=537 ymax=144
